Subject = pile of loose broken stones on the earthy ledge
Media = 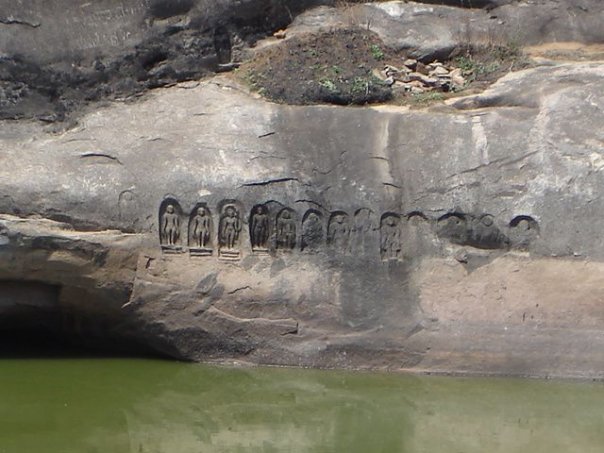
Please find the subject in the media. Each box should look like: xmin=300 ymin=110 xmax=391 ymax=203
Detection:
xmin=374 ymin=59 xmax=467 ymax=94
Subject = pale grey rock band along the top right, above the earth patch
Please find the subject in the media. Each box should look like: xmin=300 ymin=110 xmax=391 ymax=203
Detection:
xmin=289 ymin=0 xmax=604 ymax=61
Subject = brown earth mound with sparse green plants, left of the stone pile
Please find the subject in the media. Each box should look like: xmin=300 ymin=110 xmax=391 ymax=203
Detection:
xmin=238 ymin=29 xmax=392 ymax=105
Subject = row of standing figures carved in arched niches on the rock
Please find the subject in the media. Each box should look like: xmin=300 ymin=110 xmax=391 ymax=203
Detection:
xmin=159 ymin=198 xmax=539 ymax=260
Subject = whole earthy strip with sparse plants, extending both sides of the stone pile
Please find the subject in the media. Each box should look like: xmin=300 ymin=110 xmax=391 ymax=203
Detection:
xmin=237 ymin=27 xmax=530 ymax=106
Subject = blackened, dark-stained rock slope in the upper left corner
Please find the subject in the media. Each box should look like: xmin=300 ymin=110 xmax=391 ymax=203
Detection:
xmin=0 ymin=0 xmax=322 ymax=122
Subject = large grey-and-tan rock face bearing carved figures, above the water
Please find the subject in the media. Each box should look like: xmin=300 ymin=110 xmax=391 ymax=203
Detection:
xmin=0 ymin=0 xmax=604 ymax=377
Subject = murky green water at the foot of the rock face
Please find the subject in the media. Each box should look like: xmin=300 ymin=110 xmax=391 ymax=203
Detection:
xmin=0 ymin=359 xmax=604 ymax=453
